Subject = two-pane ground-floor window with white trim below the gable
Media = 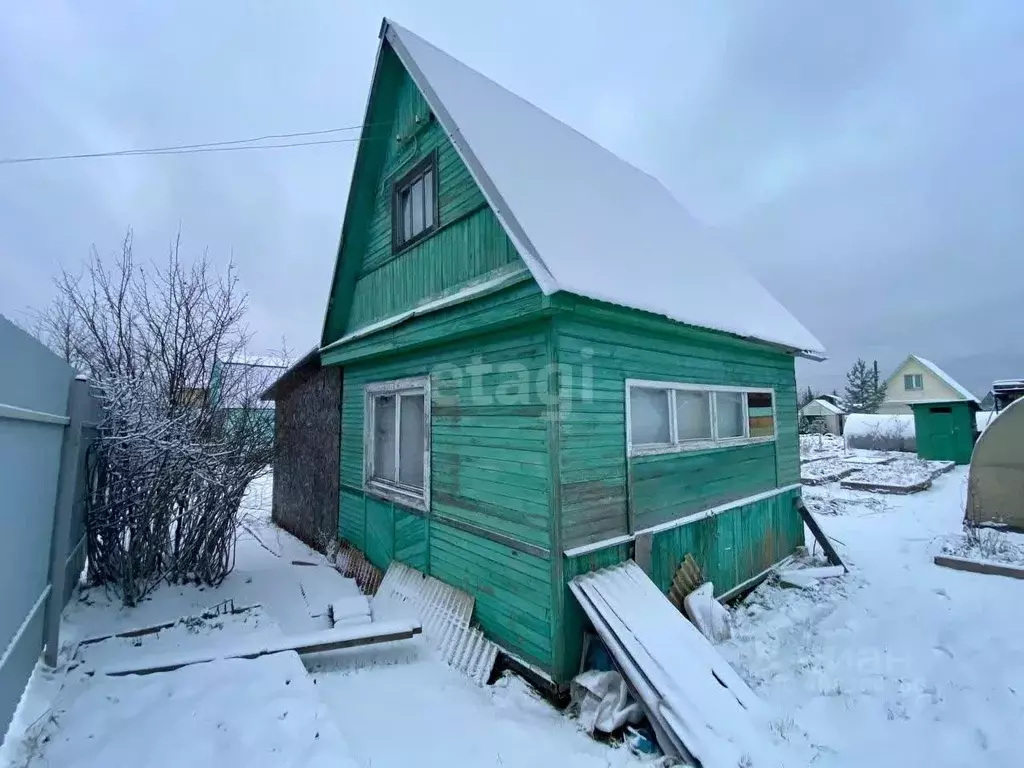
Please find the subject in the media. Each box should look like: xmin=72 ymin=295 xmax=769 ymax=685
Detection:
xmin=364 ymin=377 xmax=430 ymax=509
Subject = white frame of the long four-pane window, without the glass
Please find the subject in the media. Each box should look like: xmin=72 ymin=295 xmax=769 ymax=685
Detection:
xmin=626 ymin=379 xmax=778 ymax=458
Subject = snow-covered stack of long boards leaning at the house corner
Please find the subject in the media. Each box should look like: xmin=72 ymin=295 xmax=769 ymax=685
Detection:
xmin=570 ymin=561 xmax=777 ymax=768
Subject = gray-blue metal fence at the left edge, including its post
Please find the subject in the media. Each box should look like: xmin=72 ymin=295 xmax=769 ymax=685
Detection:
xmin=0 ymin=316 xmax=99 ymax=737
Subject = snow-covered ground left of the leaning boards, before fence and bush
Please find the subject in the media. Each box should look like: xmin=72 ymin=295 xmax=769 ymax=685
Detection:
xmin=0 ymin=478 xmax=639 ymax=768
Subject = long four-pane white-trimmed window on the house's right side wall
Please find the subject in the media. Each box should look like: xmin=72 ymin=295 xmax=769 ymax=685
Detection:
xmin=626 ymin=380 xmax=775 ymax=456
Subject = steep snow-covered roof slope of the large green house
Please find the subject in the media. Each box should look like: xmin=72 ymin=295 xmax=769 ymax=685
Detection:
xmin=381 ymin=19 xmax=823 ymax=355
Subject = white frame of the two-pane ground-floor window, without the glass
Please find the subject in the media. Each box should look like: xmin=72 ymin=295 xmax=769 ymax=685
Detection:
xmin=362 ymin=376 xmax=430 ymax=512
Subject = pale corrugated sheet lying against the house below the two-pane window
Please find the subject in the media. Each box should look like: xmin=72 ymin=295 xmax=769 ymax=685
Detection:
xmin=374 ymin=562 xmax=498 ymax=685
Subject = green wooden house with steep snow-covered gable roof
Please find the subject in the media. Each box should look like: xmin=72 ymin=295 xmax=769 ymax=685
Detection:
xmin=321 ymin=20 xmax=821 ymax=685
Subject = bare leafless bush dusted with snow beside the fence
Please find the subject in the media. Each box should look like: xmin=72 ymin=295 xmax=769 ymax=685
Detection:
xmin=40 ymin=232 xmax=275 ymax=604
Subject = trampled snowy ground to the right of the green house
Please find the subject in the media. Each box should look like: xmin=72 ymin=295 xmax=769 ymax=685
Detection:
xmin=724 ymin=468 xmax=1024 ymax=768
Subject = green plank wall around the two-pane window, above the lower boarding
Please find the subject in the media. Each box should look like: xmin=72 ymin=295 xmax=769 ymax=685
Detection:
xmin=341 ymin=325 xmax=551 ymax=547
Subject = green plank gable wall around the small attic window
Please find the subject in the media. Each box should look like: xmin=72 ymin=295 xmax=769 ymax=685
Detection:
xmin=345 ymin=60 xmax=522 ymax=332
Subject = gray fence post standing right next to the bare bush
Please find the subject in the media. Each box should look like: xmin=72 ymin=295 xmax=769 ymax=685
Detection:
xmin=43 ymin=376 xmax=89 ymax=667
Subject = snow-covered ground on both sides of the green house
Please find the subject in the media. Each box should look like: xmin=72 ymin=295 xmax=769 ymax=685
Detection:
xmin=0 ymin=465 xmax=1024 ymax=768
